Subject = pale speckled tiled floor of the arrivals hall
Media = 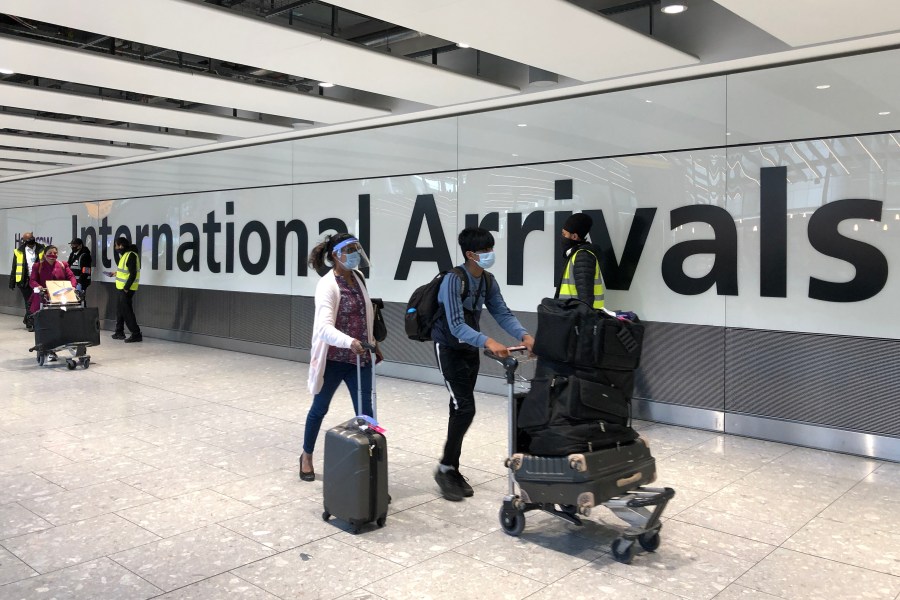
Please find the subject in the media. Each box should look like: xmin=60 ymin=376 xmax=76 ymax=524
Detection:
xmin=0 ymin=315 xmax=900 ymax=600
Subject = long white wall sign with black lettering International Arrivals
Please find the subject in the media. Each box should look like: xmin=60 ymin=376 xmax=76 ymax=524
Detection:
xmin=6 ymin=141 xmax=900 ymax=337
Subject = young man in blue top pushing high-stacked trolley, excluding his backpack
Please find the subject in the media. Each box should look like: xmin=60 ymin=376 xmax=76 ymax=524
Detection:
xmin=431 ymin=227 xmax=534 ymax=501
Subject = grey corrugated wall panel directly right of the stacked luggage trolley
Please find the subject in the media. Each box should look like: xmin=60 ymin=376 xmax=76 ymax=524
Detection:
xmin=634 ymin=321 xmax=725 ymax=410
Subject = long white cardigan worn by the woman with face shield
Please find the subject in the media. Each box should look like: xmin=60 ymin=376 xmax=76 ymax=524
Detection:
xmin=307 ymin=269 xmax=375 ymax=395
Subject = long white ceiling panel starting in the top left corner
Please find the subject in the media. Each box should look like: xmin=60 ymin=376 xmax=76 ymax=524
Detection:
xmin=0 ymin=0 xmax=518 ymax=106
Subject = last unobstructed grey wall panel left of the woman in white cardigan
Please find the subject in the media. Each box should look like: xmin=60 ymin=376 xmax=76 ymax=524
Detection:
xmin=231 ymin=292 xmax=291 ymax=346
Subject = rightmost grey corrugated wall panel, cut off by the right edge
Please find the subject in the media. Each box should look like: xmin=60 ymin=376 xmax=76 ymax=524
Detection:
xmin=725 ymin=329 xmax=900 ymax=436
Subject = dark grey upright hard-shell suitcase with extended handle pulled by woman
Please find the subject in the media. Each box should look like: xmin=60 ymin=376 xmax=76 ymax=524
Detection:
xmin=322 ymin=344 xmax=389 ymax=533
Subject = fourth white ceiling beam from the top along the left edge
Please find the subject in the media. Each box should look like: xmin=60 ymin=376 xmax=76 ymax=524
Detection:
xmin=0 ymin=113 xmax=216 ymax=148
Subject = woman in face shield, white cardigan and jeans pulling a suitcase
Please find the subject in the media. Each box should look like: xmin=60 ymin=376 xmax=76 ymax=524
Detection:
xmin=300 ymin=233 xmax=381 ymax=481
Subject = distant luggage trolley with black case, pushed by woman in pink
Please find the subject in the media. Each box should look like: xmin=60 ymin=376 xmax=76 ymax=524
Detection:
xmin=28 ymin=282 xmax=100 ymax=371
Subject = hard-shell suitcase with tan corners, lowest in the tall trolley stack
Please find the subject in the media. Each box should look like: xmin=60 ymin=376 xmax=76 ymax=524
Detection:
xmin=510 ymin=438 xmax=656 ymax=506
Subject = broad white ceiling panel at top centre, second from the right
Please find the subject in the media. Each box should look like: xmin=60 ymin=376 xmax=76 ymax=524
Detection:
xmin=330 ymin=0 xmax=699 ymax=81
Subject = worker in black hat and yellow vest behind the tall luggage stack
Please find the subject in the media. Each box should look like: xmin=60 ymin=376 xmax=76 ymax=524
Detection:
xmin=556 ymin=213 xmax=603 ymax=309
